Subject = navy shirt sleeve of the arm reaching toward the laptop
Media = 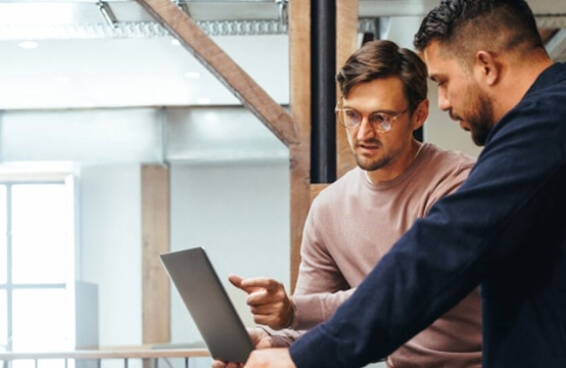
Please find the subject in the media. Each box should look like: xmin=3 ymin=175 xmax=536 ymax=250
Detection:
xmin=290 ymin=100 xmax=566 ymax=368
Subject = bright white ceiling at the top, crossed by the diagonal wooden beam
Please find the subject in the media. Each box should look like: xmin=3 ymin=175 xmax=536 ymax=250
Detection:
xmin=0 ymin=0 xmax=566 ymax=109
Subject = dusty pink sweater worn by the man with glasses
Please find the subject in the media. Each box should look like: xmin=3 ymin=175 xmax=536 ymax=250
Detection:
xmin=272 ymin=144 xmax=481 ymax=368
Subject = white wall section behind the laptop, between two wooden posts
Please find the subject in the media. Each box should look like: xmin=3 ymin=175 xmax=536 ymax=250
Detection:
xmin=171 ymin=161 xmax=290 ymax=343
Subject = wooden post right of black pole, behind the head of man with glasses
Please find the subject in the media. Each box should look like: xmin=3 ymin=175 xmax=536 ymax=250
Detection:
xmin=336 ymin=0 xmax=359 ymax=178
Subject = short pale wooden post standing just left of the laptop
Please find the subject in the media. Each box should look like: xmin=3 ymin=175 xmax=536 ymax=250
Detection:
xmin=141 ymin=165 xmax=171 ymax=344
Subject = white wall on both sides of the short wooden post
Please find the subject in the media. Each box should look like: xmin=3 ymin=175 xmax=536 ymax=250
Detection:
xmin=78 ymin=161 xmax=290 ymax=346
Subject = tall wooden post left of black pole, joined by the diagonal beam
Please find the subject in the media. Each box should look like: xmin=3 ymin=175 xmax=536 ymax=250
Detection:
xmin=288 ymin=0 xmax=311 ymax=290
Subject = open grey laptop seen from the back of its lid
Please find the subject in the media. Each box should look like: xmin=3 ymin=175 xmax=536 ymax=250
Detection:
xmin=159 ymin=247 xmax=254 ymax=363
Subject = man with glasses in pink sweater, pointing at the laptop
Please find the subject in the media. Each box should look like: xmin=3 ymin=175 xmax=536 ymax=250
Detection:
xmin=215 ymin=41 xmax=481 ymax=368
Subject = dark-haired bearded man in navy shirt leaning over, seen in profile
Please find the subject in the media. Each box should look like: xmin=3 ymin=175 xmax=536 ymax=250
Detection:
xmin=246 ymin=0 xmax=566 ymax=368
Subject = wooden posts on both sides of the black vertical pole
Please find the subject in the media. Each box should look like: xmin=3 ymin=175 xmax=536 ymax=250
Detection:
xmin=289 ymin=0 xmax=358 ymax=289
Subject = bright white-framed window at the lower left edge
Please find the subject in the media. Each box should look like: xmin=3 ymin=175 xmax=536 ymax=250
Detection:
xmin=0 ymin=181 xmax=74 ymax=351
